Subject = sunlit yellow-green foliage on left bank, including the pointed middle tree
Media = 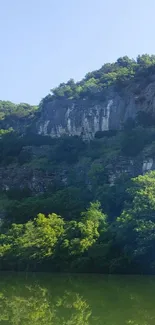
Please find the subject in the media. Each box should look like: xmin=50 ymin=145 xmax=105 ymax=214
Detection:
xmin=0 ymin=202 xmax=107 ymax=269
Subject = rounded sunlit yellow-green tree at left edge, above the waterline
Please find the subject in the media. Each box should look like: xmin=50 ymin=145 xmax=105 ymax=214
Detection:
xmin=0 ymin=214 xmax=64 ymax=265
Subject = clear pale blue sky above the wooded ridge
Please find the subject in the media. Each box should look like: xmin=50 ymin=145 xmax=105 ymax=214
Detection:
xmin=0 ymin=0 xmax=155 ymax=104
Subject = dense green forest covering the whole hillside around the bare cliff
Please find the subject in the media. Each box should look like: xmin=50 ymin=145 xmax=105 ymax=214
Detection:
xmin=0 ymin=55 xmax=155 ymax=273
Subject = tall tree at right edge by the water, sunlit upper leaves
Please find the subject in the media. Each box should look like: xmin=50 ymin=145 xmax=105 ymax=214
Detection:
xmin=117 ymin=171 xmax=155 ymax=271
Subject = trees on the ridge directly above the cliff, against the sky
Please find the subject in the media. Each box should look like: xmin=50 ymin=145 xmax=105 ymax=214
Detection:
xmin=40 ymin=54 xmax=155 ymax=107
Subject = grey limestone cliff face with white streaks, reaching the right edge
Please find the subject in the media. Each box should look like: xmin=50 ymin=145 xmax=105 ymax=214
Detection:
xmin=36 ymin=82 xmax=155 ymax=140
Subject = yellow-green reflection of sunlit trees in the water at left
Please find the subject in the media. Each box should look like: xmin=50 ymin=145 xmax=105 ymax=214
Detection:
xmin=0 ymin=274 xmax=91 ymax=325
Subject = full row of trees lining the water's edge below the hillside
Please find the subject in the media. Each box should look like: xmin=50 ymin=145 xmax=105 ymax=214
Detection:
xmin=0 ymin=171 xmax=155 ymax=273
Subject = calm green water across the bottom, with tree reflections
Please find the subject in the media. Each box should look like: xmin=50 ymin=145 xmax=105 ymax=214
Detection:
xmin=0 ymin=273 xmax=155 ymax=325
